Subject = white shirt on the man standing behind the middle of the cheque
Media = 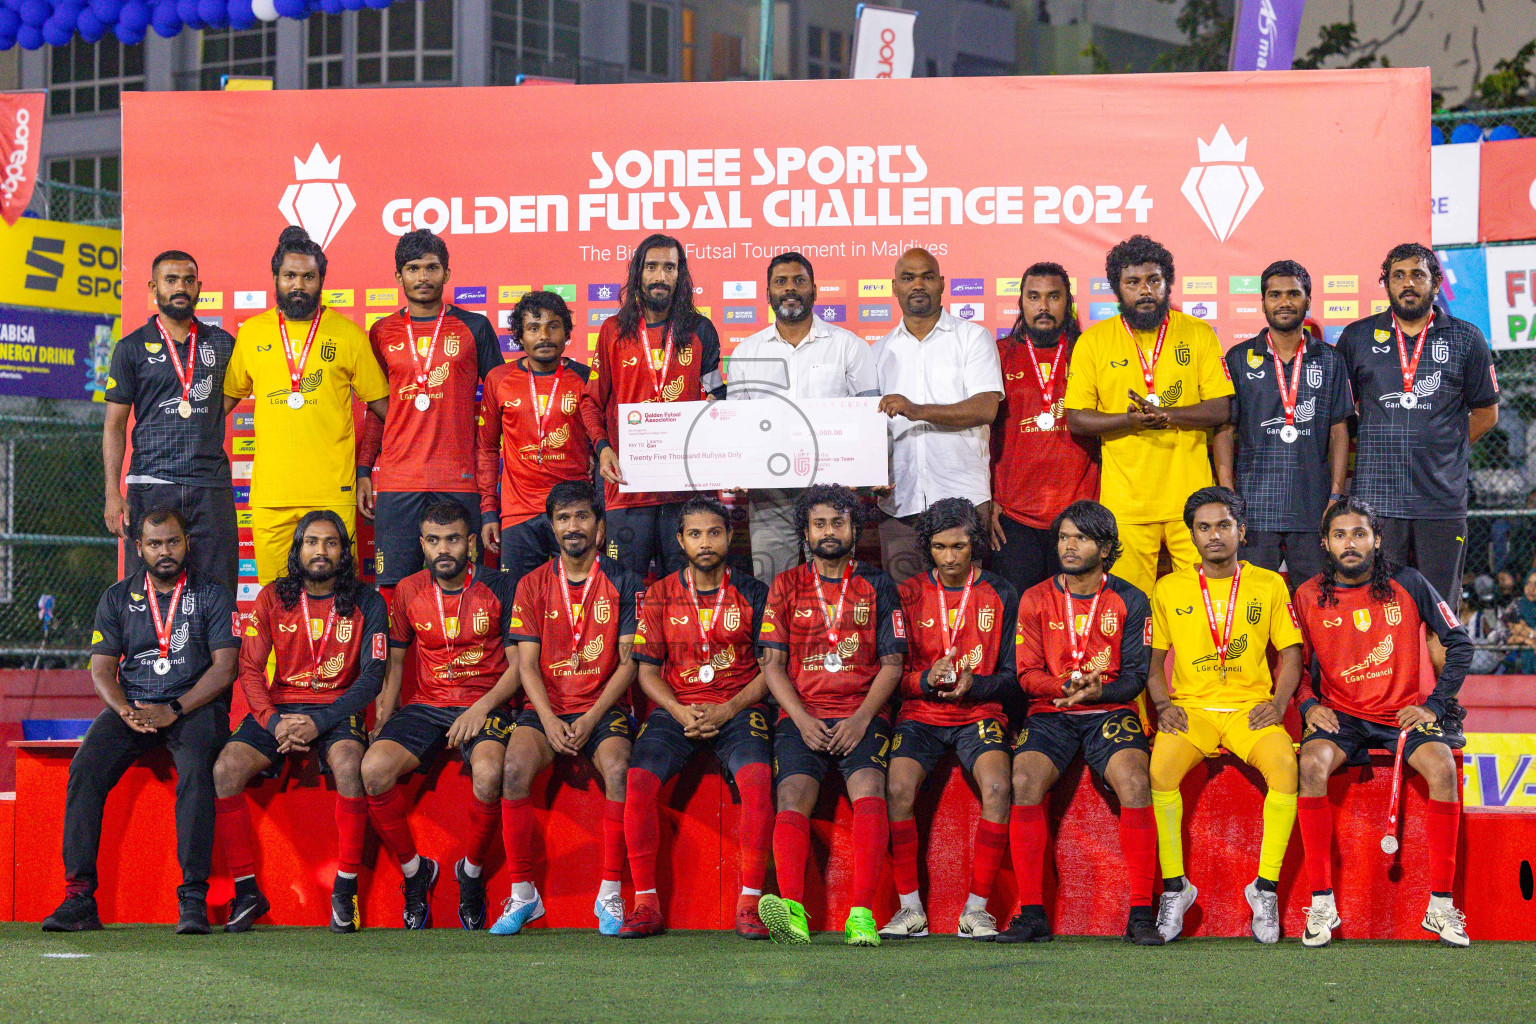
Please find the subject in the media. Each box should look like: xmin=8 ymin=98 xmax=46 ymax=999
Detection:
xmin=727 ymin=316 xmax=880 ymax=399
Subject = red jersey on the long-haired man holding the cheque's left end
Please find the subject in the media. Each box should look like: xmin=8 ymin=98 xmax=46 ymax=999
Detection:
xmin=581 ymin=316 xmax=725 ymax=508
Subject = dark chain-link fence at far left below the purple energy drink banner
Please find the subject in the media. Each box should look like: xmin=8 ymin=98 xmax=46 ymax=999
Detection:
xmin=0 ymin=398 xmax=117 ymax=668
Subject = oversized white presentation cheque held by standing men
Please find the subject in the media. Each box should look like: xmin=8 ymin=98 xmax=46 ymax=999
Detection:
xmin=619 ymin=396 xmax=891 ymax=491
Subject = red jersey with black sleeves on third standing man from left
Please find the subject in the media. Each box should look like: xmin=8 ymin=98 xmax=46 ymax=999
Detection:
xmin=359 ymin=306 xmax=502 ymax=494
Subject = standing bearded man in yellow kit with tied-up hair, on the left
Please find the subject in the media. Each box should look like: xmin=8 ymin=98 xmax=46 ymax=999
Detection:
xmin=224 ymin=227 xmax=389 ymax=583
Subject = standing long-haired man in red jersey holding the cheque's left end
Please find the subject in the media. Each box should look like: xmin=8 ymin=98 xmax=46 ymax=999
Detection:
xmin=581 ymin=235 xmax=725 ymax=580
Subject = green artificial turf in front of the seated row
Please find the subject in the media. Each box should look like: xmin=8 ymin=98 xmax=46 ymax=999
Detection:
xmin=0 ymin=924 xmax=1536 ymax=1024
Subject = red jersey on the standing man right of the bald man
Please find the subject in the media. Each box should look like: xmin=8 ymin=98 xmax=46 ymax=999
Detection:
xmin=992 ymin=338 xmax=1098 ymax=530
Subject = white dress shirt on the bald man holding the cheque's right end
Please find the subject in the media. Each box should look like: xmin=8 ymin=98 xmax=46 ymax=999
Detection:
xmin=874 ymin=313 xmax=1003 ymax=516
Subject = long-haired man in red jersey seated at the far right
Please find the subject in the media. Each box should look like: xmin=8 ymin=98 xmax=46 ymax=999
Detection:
xmin=1296 ymin=497 xmax=1471 ymax=946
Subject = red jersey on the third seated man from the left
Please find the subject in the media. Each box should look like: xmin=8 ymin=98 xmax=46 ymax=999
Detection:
xmin=389 ymin=565 xmax=513 ymax=708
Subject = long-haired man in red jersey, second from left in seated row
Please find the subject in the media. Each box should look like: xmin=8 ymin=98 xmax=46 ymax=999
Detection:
xmin=214 ymin=510 xmax=389 ymax=932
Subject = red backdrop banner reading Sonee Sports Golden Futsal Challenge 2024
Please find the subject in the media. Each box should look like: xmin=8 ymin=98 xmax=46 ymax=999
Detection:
xmin=123 ymin=69 xmax=1430 ymax=599
